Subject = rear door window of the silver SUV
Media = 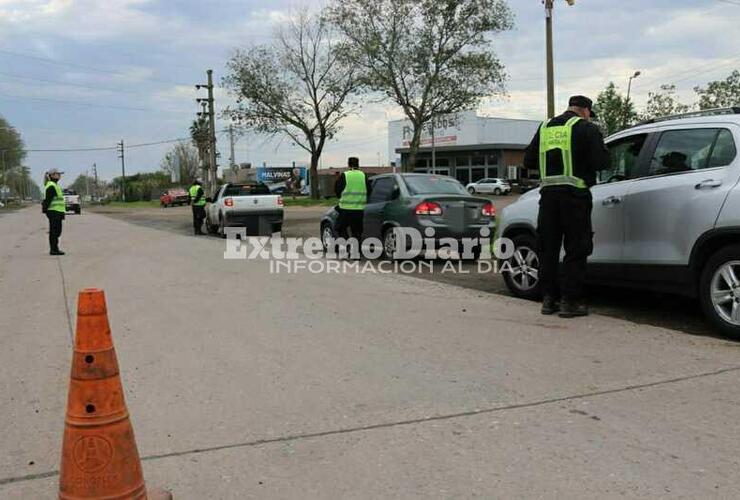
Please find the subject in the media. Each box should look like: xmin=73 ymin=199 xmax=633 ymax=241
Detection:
xmin=648 ymin=128 xmax=736 ymax=176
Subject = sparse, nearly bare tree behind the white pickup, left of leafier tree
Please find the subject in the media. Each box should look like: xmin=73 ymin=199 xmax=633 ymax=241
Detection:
xmin=224 ymin=12 xmax=360 ymax=199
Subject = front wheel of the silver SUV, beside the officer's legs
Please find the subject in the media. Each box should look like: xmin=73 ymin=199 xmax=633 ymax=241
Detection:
xmin=502 ymin=234 xmax=542 ymax=300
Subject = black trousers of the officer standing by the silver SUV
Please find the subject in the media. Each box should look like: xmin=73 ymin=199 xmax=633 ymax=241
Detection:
xmin=537 ymin=189 xmax=593 ymax=301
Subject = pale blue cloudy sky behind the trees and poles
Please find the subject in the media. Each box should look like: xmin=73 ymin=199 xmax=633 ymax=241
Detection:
xmin=0 ymin=0 xmax=740 ymax=184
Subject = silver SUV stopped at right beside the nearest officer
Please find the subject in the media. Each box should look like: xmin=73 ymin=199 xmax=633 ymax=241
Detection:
xmin=497 ymin=108 xmax=740 ymax=338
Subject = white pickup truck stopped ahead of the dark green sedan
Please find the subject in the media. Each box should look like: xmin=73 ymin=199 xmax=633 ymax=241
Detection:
xmin=206 ymin=182 xmax=283 ymax=236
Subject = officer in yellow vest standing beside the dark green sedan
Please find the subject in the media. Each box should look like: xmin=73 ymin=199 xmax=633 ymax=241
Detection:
xmin=334 ymin=156 xmax=370 ymax=243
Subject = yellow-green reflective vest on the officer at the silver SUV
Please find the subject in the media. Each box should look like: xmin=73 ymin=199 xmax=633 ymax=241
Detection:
xmin=540 ymin=116 xmax=588 ymax=189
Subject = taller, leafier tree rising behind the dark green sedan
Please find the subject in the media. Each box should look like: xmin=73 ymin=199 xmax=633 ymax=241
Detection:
xmin=327 ymin=0 xmax=513 ymax=170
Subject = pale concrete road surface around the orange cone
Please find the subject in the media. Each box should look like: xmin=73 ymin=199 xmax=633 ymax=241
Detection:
xmin=0 ymin=205 xmax=740 ymax=499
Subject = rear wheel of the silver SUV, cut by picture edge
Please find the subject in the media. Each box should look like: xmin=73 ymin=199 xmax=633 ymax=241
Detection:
xmin=699 ymin=245 xmax=740 ymax=339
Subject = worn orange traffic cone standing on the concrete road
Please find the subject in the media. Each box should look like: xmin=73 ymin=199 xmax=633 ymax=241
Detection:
xmin=59 ymin=289 xmax=172 ymax=500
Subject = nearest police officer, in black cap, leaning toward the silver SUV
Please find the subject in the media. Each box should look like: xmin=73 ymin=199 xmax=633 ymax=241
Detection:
xmin=524 ymin=96 xmax=608 ymax=318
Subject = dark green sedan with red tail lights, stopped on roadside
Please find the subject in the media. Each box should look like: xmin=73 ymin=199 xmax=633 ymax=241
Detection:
xmin=319 ymin=174 xmax=496 ymax=257
